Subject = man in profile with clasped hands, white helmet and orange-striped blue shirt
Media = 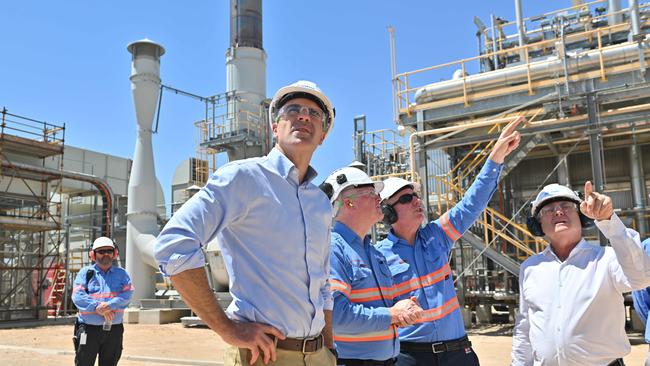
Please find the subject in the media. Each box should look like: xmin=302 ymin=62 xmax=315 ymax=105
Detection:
xmin=321 ymin=167 xmax=422 ymax=366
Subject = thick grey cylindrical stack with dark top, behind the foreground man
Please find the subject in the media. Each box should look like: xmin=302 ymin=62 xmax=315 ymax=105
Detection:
xmin=225 ymin=0 xmax=266 ymax=161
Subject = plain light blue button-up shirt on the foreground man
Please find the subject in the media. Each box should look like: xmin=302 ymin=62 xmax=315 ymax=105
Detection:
xmin=155 ymin=149 xmax=332 ymax=337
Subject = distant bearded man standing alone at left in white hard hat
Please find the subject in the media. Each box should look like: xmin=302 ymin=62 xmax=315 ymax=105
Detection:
xmin=72 ymin=236 xmax=133 ymax=366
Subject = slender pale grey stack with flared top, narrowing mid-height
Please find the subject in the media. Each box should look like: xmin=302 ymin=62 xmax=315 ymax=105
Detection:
xmin=126 ymin=39 xmax=165 ymax=300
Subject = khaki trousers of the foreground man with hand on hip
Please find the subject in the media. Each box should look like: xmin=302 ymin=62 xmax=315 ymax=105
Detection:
xmin=223 ymin=346 xmax=336 ymax=366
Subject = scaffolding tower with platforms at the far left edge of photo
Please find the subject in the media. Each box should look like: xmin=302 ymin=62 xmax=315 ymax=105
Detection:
xmin=0 ymin=108 xmax=65 ymax=321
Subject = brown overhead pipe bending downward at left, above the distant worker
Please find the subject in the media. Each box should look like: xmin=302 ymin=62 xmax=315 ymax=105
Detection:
xmin=2 ymin=161 xmax=115 ymax=238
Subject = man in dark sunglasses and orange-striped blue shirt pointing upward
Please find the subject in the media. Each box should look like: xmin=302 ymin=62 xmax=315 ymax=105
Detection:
xmin=377 ymin=118 xmax=523 ymax=366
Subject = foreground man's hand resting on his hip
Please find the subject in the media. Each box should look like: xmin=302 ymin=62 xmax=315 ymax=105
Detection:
xmin=220 ymin=320 xmax=285 ymax=365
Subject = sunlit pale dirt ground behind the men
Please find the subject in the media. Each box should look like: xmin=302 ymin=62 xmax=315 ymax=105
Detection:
xmin=0 ymin=324 xmax=648 ymax=366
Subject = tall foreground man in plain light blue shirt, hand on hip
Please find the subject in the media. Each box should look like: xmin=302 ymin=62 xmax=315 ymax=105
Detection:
xmin=155 ymin=81 xmax=336 ymax=365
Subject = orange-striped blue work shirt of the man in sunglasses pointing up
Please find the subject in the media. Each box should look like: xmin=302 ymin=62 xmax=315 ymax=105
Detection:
xmin=377 ymin=159 xmax=501 ymax=343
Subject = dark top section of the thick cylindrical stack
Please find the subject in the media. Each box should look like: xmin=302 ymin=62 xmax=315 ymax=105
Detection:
xmin=230 ymin=0 xmax=264 ymax=50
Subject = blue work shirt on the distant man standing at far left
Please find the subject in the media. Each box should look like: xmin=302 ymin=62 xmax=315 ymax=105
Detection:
xmin=72 ymin=263 xmax=133 ymax=325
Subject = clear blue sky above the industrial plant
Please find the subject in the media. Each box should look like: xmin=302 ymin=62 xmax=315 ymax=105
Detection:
xmin=0 ymin=0 xmax=556 ymax=209
